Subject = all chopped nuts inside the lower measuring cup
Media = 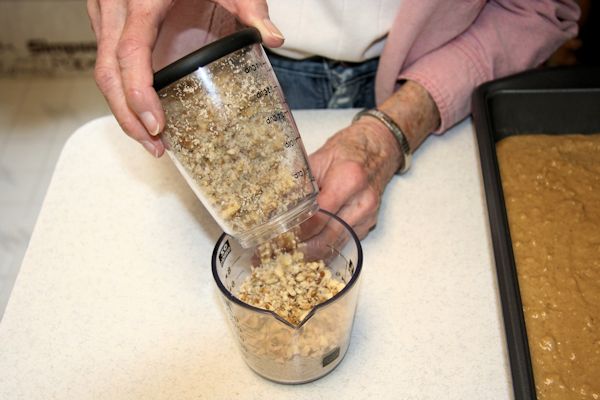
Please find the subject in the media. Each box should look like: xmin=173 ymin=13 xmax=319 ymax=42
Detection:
xmin=230 ymin=232 xmax=355 ymax=382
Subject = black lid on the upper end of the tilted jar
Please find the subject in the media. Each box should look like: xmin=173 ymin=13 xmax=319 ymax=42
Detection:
xmin=153 ymin=28 xmax=262 ymax=92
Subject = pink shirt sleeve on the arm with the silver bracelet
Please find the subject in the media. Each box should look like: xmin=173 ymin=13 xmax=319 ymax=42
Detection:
xmin=399 ymin=0 xmax=579 ymax=133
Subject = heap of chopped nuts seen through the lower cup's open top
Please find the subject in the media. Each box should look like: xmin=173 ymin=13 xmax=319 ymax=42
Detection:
xmin=238 ymin=232 xmax=344 ymax=325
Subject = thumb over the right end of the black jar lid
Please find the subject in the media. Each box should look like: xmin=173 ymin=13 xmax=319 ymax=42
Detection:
xmin=215 ymin=0 xmax=285 ymax=47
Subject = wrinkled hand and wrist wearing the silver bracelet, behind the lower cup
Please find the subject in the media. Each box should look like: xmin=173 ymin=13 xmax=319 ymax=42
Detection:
xmin=310 ymin=81 xmax=440 ymax=239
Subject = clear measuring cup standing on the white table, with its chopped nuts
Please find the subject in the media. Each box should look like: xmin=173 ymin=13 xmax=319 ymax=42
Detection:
xmin=212 ymin=210 xmax=362 ymax=383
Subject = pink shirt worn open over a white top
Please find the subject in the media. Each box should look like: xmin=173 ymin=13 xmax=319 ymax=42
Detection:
xmin=153 ymin=0 xmax=579 ymax=133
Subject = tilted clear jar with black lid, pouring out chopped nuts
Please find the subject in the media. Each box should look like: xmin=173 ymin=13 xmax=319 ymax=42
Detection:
xmin=154 ymin=28 xmax=318 ymax=247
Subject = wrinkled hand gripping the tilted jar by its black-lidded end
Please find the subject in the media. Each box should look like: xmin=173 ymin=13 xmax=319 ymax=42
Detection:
xmin=87 ymin=0 xmax=283 ymax=157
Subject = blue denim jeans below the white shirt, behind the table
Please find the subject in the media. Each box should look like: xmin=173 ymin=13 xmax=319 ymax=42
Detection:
xmin=267 ymin=52 xmax=379 ymax=109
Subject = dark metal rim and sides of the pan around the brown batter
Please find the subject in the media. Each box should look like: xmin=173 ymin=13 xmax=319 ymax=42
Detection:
xmin=472 ymin=67 xmax=600 ymax=400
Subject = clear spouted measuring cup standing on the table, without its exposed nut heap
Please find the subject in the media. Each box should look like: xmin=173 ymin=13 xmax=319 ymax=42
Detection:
xmin=212 ymin=210 xmax=362 ymax=383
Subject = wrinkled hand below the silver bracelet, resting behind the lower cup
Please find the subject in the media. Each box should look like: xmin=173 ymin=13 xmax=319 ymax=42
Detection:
xmin=310 ymin=117 xmax=403 ymax=239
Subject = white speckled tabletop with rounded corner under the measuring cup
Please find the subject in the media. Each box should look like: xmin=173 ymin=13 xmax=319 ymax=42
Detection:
xmin=0 ymin=110 xmax=512 ymax=400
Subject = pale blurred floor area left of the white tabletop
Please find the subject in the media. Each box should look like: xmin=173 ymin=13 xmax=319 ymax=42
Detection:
xmin=0 ymin=76 xmax=109 ymax=319
